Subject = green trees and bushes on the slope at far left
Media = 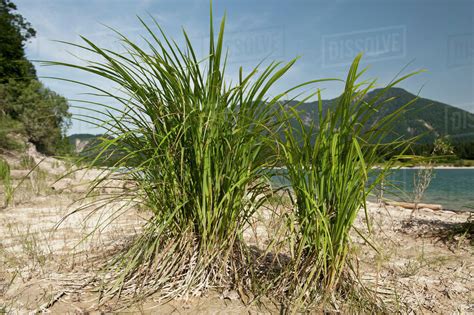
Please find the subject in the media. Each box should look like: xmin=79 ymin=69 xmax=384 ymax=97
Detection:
xmin=0 ymin=0 xmax=71 ymax=155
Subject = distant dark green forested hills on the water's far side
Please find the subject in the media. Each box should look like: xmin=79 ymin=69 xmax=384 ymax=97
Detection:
xmin=69 ymin=88 xmax=474 ymax=159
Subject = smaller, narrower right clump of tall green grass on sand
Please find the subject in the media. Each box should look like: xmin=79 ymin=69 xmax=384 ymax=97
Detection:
xmin=280 ymin=55 xmax=415 ymax=307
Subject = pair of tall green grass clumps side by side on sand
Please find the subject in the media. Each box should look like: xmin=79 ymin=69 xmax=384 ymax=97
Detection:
xmin=49 ymin=6 xmax=418 ymax=310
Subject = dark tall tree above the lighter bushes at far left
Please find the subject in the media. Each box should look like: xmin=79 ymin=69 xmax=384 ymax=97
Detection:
xmin=0 ymin=0 xmax=36 ymax=83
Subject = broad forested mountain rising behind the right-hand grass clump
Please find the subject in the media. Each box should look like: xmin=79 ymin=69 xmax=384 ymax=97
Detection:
xmin=290 ymin=88 xmax=474 ymax=144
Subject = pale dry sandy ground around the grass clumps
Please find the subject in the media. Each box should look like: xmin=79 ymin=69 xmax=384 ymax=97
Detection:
xmin=0 ymin=152 xmax=474 ymax=314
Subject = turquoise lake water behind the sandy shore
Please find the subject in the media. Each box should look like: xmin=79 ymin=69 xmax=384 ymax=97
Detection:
xmin=272 ymin=168 xmax=474 ymax=211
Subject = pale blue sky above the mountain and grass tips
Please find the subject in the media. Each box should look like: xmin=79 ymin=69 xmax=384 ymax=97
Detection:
xmin=15 ymin=0 xmax=474 ymax=133
